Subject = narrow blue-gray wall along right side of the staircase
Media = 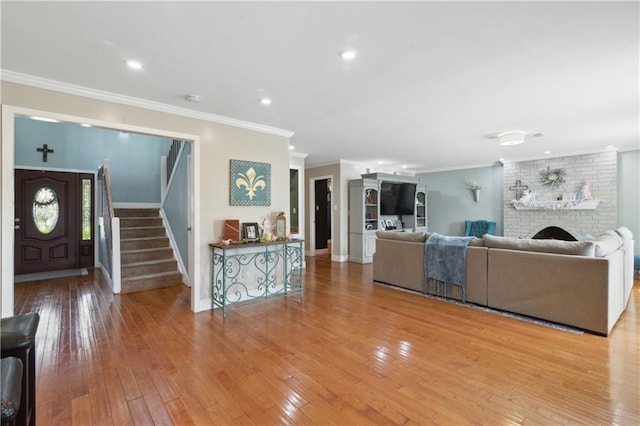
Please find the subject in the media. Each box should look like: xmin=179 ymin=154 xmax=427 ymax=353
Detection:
xmin=163 ymin=142 xmax=191 ymax=268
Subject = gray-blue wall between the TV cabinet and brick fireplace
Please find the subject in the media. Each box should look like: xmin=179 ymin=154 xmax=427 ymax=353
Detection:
xmin=416 ymin=165 xmax=504 ymax=236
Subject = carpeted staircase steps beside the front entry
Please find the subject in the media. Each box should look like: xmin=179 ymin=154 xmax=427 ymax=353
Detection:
xmin=115 ymin=209 xmax=182 ymax=293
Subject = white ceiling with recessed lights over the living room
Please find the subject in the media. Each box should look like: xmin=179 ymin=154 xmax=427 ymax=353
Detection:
xmin=1 ymin=1 xmax=640 ymax=172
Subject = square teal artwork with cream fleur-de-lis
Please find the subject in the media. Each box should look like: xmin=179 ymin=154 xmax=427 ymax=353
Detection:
xmin=229 ymin=160 xmax=271 ymax=206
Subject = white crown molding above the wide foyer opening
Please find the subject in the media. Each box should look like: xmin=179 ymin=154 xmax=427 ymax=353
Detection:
xmin=0 ymin=69 xmax=294 ymax=138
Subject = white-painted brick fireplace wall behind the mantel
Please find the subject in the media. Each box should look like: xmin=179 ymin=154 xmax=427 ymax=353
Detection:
xmin=503 ymin=151 xmax=618 ymax=239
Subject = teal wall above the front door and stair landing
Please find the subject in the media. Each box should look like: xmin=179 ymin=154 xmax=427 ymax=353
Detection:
xmin=15 ymin=117 xmax=171 ymax=203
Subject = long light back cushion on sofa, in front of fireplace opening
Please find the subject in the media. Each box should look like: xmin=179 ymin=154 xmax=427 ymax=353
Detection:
xmin=483 ymin=235 xmax=596 ymax=257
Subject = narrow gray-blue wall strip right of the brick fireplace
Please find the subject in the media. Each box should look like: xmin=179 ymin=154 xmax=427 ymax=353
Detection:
xmin=618 ymin=150 xmax=640 ymax=255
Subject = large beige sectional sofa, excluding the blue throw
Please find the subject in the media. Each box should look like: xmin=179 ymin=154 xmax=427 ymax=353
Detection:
xmin=373 ymin=227 xmax=633 ymax=335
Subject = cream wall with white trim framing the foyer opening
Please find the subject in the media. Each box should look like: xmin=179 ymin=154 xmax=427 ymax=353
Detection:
xmin=0 ymin=81 xmax=289 ymax=317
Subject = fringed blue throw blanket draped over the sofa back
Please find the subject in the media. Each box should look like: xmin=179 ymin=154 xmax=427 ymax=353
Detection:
xmin=423 ymin=233 xmax=476 ymax=302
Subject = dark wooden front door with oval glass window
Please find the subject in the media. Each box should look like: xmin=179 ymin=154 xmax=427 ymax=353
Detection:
xmin=14 ymin=170 xmax=93 ymax=275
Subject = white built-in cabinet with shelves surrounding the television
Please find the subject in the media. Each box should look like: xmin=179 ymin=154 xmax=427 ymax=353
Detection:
xmin=349 ymin=173 xmax=427 ymax=263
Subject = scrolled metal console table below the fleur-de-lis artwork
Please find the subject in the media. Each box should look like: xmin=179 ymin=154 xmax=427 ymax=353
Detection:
xmin=209 ymin=240 xmax=304 ymax=318
